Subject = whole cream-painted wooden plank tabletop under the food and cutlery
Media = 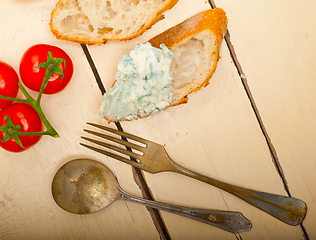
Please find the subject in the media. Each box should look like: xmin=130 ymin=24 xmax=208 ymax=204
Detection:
xmin=0 ymin=0 xmax=316 ymax=240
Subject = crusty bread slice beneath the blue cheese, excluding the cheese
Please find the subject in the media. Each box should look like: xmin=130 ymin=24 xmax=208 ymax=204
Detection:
xmin=100 ymin=8 xmax=228 ymax=122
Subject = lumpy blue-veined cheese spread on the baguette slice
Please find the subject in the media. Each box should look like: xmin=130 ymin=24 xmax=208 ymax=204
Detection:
xmin=99 ymin=43 xmax=173 ymax=121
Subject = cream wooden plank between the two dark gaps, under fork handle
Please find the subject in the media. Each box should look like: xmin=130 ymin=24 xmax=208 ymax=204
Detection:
xmin=89 ymin=0 xmax=303 ymax=239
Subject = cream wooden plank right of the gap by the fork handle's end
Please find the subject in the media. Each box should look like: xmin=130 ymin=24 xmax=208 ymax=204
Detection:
xmin=216 ymin=0 xmax=316 ymax=239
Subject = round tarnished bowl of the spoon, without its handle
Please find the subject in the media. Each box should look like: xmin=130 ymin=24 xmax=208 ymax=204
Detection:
xmin=52 ymin=159 xmax=119 ymax=214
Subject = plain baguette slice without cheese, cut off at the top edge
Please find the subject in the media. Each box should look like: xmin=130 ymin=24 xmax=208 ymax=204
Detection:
xmin=50 ymin=0 xmax=178 ymax=45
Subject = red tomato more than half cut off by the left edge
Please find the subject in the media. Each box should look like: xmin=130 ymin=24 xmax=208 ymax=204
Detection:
xmin=0 ymin=61 xmax=19 ymax=109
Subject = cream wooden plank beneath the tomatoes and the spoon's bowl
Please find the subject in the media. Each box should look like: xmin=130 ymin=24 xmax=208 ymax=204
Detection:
xmin=0 ymin=0 xmax=160 ymax=240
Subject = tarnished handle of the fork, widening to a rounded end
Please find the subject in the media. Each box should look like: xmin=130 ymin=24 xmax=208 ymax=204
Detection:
xmin=173 ymin=162 xmax=307 ymax=226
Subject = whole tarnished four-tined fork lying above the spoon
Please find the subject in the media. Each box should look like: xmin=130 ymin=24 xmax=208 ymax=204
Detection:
xmin=80 ymin=123 xmax=307 ymax=226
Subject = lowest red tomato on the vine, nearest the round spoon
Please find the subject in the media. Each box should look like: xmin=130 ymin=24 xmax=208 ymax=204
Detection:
xmin=0 ymin=102 xmax=43 ymax=152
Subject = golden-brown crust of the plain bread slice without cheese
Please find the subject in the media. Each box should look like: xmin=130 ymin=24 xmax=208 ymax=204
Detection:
xmin=49 ymin=0 xmax=179 ymax=45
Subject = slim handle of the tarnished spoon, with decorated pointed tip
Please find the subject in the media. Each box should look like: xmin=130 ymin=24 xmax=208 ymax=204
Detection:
xmin=119 ymin=189 xmax=252 ymax=234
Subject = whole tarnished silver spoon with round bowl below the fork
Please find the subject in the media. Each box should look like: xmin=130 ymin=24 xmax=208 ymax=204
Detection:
xmin=52 ymin=159 xmax=252 ymax=233
